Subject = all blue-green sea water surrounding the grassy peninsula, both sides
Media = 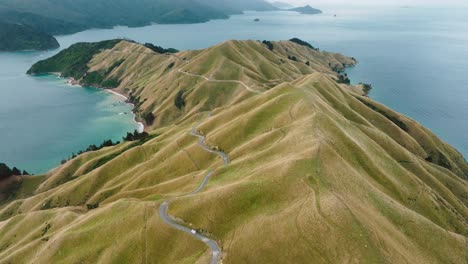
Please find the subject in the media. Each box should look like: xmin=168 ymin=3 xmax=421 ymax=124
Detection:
xmin=0 ymin=6 xmax=468 ymax=171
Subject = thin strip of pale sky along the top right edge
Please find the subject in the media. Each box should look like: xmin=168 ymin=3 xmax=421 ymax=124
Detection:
xmin=268 ymin=0 xmax=468 ymax=6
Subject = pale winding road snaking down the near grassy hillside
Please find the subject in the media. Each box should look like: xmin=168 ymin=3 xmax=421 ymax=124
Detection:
xmin=159 ymin=119 xmax=230 ymax=264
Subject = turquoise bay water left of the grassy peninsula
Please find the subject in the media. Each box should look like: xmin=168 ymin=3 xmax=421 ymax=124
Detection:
xmin=0 ymin=52 xmax=137 ymax=173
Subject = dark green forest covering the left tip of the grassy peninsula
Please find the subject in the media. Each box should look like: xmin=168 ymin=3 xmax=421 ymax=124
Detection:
xmin=27 ymin=39 xmax=122 ymax=78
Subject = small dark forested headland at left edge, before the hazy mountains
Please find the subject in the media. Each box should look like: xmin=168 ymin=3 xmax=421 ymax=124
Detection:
xmin=0 ymin=20 xmax=59 ymax=51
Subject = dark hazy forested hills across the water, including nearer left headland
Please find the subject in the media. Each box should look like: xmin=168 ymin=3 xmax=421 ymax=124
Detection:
xmin=0 ymin=0 xmax=277 ymax=51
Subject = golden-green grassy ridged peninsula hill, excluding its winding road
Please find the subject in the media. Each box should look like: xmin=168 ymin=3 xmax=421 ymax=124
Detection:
xmin=0 ymin=41 xmax=468 ymax=263
